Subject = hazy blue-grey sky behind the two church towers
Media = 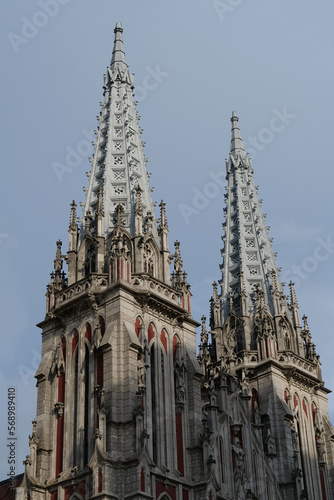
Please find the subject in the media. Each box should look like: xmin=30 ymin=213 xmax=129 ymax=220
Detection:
xmin=0 ymin=0 xmax=334 ymax=479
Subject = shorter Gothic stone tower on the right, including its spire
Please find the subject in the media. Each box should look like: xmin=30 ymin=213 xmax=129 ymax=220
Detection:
xmin=200 ymin=113 xmax=334 ymax=500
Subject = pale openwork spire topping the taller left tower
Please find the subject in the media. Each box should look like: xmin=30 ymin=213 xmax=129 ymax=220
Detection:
xmin=80 ymin=23 xmax=158 ymax=242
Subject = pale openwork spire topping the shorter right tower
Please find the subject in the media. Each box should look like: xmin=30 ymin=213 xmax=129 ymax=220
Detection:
xmin=221 ymin=112 xmax=283 ymax=322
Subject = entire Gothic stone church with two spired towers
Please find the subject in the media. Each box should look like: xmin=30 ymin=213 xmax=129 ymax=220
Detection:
xmin=16 ymin=23 xmax=334 ymax=500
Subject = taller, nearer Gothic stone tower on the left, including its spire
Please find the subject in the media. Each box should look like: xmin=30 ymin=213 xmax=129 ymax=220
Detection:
xmin=18 ymin=23 xmax=202 ymax=500
